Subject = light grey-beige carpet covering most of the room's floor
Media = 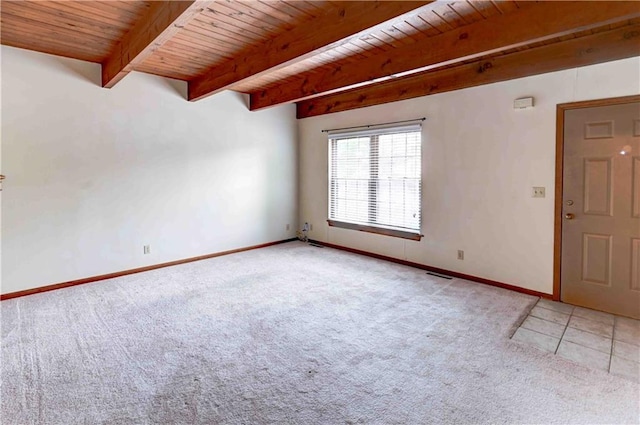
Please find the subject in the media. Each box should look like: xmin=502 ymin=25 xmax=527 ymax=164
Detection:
xmin=0 ymin=242 xmax=640 ymax=425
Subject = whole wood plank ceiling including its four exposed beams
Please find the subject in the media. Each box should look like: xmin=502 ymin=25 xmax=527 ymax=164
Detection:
xmin=0 ymin=0 xmax=640 ymax=118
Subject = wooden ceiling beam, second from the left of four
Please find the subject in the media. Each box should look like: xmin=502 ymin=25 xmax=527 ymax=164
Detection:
xmin=189 ymin=1 xmax=431 ymax=101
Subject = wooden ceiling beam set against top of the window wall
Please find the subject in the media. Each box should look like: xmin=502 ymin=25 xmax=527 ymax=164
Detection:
xmin=297 ymin=24 xmax=640 ymax=118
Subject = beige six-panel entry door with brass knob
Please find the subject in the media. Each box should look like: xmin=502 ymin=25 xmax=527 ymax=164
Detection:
xmin=560 ymin=102 xmax=640 ymax=319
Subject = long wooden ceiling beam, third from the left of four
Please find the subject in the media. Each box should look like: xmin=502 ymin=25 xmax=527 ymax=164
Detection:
xmin=250 ymin=1 xmax=640 ymax=110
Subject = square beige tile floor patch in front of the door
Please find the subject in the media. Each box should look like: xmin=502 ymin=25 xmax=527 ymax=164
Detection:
xmin=512 ymin=299 xmax=640 ymax=382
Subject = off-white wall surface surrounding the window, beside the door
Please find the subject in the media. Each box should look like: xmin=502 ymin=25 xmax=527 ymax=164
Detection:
xmin=299 ymin=57 xmax=640 ymax=294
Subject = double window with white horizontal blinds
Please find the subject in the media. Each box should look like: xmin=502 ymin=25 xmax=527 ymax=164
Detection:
xmin=329 ymin=124 xmax=421 ymax=240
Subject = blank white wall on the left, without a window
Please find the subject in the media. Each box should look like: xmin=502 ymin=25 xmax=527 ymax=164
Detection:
xmin=1 ymin=46 xmax=298 ymax=293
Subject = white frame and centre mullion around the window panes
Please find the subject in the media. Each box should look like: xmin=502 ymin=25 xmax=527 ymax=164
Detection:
xmin=327 ymin=123 xmax=423 ymax=240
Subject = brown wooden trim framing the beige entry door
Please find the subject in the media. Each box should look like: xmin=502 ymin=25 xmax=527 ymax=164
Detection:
xmin=553 ymin=95 xmax=640 ymax=301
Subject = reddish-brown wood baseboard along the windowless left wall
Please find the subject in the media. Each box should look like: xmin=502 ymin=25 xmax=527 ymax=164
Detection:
xmin=0 ymin=238 xmax=297 ymax=301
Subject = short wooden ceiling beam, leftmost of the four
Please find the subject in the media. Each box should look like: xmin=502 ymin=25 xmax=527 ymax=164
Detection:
xmin=102 ymin=0 xmax=209 ymax=88
